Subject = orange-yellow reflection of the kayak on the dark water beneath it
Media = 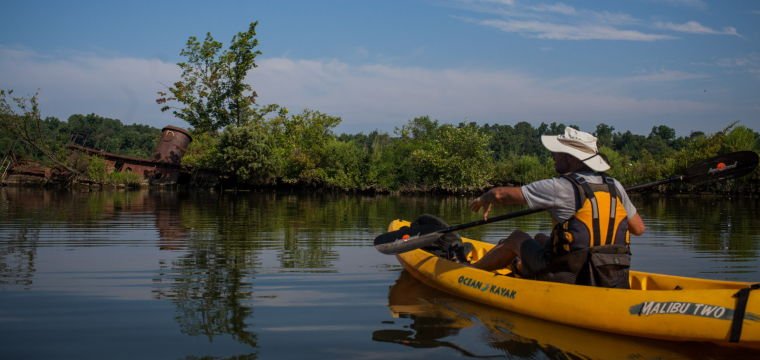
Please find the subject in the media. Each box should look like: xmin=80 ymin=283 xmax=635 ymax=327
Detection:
xmin=380 ymin=272 xmax=760 ymax=359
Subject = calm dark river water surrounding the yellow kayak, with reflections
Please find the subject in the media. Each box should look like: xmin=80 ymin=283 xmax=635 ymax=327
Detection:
xmin=0 ymin=188 xmax=760 ymax=359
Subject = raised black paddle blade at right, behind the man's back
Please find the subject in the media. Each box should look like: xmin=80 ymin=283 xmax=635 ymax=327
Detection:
xmin=683 ymin=151 xmax=758 ymax=184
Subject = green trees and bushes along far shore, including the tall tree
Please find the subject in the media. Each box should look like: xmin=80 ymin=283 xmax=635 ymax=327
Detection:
xmin=0 ymin=22 xmax=760 ymax=194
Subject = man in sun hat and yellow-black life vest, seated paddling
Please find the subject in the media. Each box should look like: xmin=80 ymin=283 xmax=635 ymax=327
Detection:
xmin=470 ymin=127 xmax=645 ymax=287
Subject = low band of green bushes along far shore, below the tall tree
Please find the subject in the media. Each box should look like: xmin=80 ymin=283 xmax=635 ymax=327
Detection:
xmin=0 ymin=101 xmax=760 ymax=194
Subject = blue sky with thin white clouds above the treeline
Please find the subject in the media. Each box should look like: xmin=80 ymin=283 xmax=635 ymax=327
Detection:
xmin=0 ymin=0 xmax=760 ymax=135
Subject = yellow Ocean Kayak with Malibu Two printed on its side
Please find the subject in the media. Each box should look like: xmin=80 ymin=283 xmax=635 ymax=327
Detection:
xmin=388 ymin=220 xmax=760 ymax=349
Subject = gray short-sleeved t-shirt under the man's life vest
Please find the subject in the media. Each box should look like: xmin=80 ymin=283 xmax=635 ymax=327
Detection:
xmin=520 ymin=172 xmax=636 ymax=223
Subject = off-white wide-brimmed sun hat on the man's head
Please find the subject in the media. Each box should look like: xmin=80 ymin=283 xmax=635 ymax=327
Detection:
xmin=541 ymin=127 xmax=610 ymax=172
